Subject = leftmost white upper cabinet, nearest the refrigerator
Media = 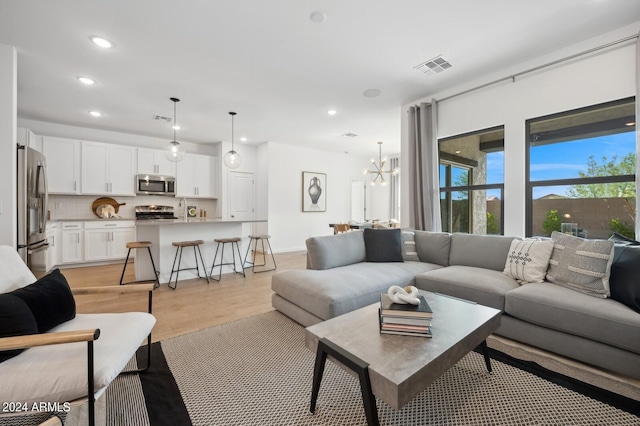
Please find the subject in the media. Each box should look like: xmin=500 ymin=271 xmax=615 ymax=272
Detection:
xmin=42 ymin=136 xmax=80 ymax=194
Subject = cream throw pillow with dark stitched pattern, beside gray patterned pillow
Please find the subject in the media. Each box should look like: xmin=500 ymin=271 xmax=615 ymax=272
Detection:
xmin=503 ymin=239 xmax=553 ymax=284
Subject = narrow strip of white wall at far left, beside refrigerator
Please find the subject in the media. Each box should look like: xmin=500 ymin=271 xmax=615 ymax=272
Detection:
xmin=0 ymin=44 xmax=18 ymax=247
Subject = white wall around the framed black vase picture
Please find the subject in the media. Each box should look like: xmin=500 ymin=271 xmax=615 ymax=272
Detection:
xmin=268 ymin=142 xmax=370 ymax=252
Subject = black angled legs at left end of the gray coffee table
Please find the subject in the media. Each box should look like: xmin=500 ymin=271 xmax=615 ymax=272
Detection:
xmin=310 ymin=338 xmax=379 ymax=426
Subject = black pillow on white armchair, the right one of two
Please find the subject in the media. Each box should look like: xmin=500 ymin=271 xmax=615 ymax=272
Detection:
xmin=9 ymin=269 xmax=76 ymax=333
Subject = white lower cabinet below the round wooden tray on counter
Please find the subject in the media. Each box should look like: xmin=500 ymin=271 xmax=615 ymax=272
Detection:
xmin=84 ymin=221 xmax=135 ymax=262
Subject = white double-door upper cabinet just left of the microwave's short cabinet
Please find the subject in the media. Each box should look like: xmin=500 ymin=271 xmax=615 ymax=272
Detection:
xmin=82 ymin=142 xmax=136 ymax=195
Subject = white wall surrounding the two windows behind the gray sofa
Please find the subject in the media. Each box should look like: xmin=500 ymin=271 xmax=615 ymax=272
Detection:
xmin=401 ymin=23 xmax=640 ymax=235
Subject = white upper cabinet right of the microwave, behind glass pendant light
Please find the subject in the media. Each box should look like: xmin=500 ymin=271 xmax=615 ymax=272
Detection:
xmin=176 ymin=154 xmax=217 ymax=198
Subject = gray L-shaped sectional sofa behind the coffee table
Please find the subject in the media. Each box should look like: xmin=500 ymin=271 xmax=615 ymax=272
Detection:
xmin=272 ymin=231 xmax=640 ymax=379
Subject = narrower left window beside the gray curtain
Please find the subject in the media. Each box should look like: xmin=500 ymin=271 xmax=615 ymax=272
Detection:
xmin=438 ymin=126 xmax=504 ymax=234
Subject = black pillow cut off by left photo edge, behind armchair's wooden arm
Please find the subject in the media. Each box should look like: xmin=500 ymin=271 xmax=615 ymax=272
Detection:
xmin=0 ymin=293 xmax=38 ymax=362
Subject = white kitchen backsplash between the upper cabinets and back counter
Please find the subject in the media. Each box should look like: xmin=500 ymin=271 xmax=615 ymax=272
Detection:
xmin=49 ymin=195 xmax=217 ymax=220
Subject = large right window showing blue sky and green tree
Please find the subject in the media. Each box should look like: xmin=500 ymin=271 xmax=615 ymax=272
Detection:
xmin=526 ymin=98 xmax=636 ymax=238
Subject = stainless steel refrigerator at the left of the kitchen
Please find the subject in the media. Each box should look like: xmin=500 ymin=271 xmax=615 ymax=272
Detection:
xmin=18 ymin=145 xmax=49 ymax=267
